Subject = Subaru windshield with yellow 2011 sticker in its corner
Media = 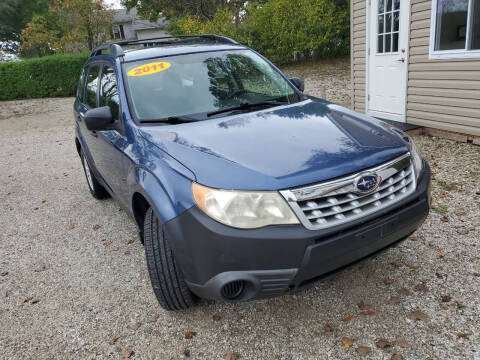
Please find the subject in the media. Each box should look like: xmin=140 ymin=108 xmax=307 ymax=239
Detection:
xmin=125 ymin=50 xmax=300 ymax=121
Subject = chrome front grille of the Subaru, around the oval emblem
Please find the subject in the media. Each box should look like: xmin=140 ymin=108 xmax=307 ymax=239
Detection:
xmin=281 ymin=154 xmax=416 ymax=230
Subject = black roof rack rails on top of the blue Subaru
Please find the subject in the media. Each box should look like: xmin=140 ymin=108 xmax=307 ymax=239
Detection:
xmin=90 ymin=34 xmax=238 ymax=57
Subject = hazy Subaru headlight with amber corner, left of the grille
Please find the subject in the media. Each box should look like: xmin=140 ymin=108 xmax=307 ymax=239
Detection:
xmin=192 ymin=183 xmax=299 ymax=229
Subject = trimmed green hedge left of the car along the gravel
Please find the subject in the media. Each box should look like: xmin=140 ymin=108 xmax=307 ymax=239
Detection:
xmin=0 ymin=54 xmax=88 ymax=100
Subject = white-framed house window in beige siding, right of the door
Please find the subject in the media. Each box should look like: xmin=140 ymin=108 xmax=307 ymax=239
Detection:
xmin=430 ymin=0 xmax=480 ymax=59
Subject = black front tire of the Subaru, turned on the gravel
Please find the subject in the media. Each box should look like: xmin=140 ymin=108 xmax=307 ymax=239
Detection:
xmin=144 ymin=208 xmax=197 ymax=310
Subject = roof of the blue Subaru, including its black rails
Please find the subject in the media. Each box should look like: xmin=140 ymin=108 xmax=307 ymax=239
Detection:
xmin=90 ymin=35 xmax=247 ymax=62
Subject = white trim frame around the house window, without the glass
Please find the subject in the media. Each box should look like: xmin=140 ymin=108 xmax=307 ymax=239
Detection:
xmin=428 ymin=0 xmax=480 ymax=60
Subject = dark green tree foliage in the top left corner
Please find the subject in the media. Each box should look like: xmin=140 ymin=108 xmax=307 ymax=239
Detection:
xmin=0 ymin=0 xmax=48 ymax=41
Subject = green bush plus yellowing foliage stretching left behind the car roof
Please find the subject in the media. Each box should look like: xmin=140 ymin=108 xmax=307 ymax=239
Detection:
xmin=171 ymin=0 xmax=350 ymax=64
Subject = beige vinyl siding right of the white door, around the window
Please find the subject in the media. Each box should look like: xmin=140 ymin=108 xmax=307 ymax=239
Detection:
xmin=407 ymin=0 xmax=480 ymax=135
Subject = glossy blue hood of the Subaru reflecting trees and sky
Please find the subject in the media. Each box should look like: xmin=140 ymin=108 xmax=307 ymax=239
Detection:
xmin=139 ymin=99 xmax=408 ymax=190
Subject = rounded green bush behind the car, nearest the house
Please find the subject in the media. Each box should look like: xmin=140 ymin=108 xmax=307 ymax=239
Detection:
xmin=248 ymin=0 xmax=350 ymax=63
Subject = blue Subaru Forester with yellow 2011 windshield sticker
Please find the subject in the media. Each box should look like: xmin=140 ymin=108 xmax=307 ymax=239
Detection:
xmin=74 ymin=35 xmax=430 ymax=310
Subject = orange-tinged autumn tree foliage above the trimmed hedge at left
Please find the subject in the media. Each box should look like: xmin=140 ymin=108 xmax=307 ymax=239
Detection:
xmin=20 ymin=0 xmax=113 ymax=57
